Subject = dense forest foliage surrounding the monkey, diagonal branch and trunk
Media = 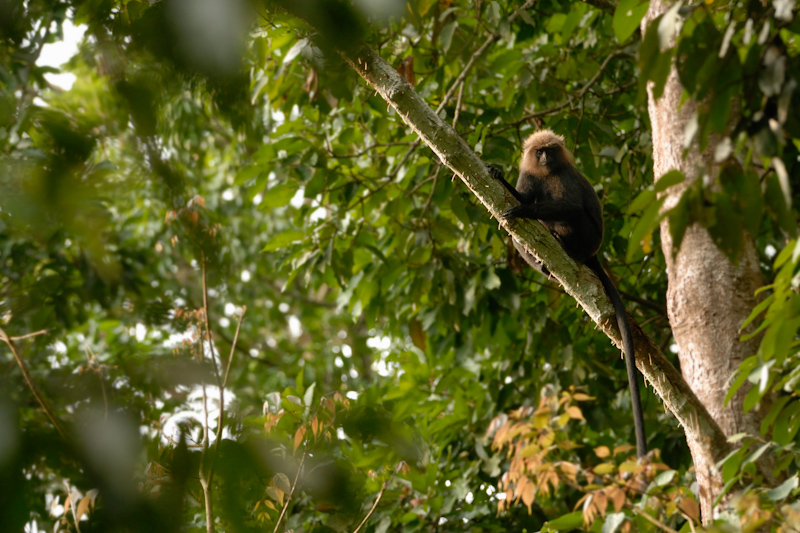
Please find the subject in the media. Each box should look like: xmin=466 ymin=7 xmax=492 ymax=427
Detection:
xmin=0 ymin=0 xmax=800 ymax=532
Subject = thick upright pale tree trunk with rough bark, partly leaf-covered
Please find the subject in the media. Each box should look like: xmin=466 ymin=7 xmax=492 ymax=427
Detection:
xmin=642 ymin=0 xmax=764 ymax=522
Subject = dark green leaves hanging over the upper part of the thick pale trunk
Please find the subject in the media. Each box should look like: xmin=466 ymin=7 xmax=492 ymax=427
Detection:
xmin=618 ymin=1 xmax=800 ymax=261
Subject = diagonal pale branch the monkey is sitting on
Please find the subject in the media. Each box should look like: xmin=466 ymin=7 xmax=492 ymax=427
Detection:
xmin=275 ymin=0 xmax=731 ymax=459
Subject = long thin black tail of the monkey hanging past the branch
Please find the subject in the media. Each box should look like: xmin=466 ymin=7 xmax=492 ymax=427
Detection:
xmin=586 ymin=255 xmax=647 ymax=458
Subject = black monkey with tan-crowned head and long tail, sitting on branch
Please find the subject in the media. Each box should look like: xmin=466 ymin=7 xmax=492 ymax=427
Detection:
xmin=491 ymin=130 xmax=647 ymax=457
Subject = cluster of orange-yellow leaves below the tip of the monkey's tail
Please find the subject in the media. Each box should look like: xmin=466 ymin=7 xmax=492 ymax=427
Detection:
xmin=489 ymin=390 xmax=700 ymax=531
